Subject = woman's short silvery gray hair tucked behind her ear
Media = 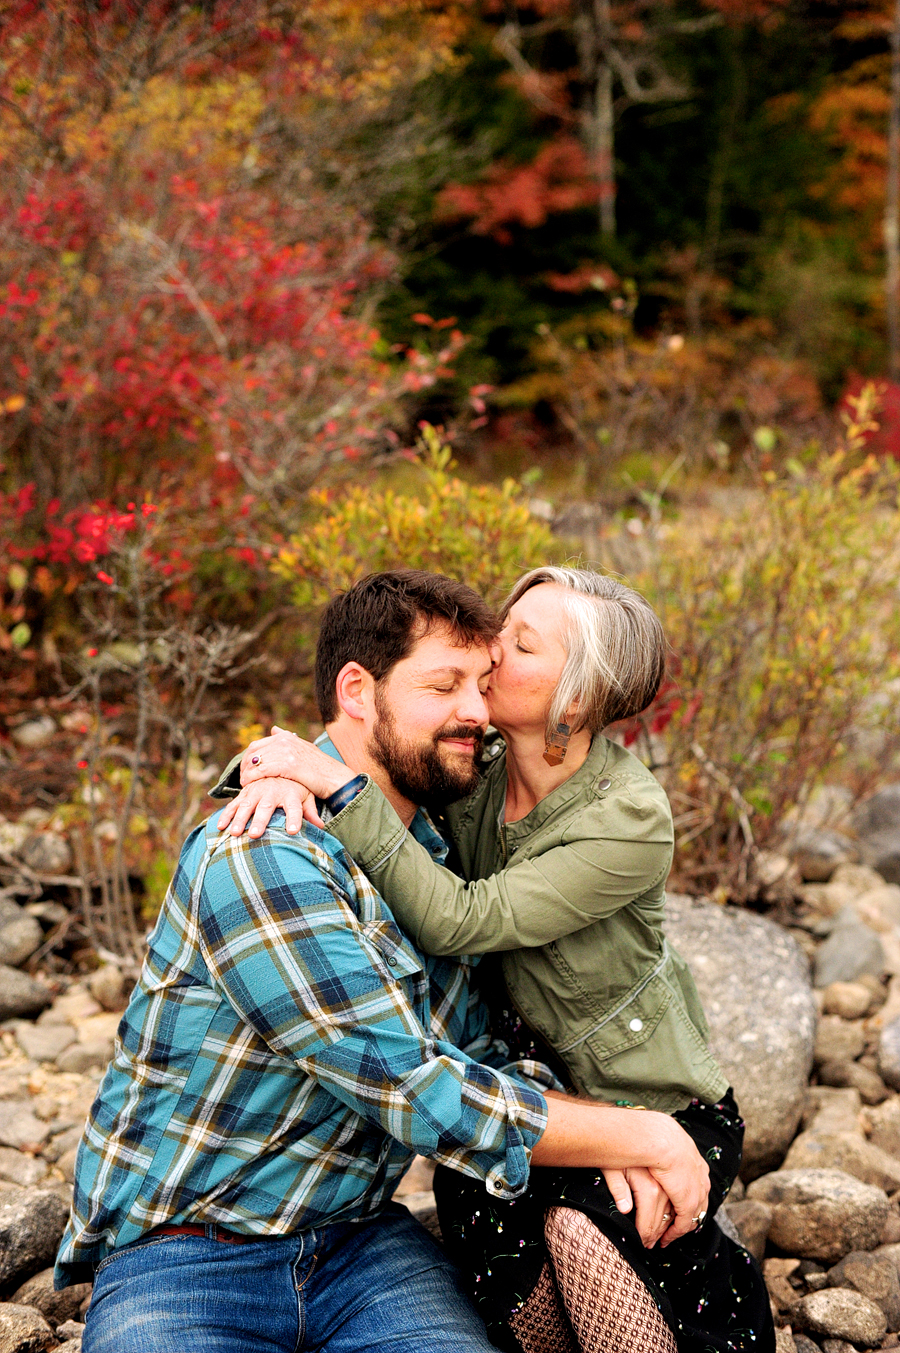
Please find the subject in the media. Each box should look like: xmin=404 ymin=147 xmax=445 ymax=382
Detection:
xmin=501 ymin=567 xmax=666 ymax=735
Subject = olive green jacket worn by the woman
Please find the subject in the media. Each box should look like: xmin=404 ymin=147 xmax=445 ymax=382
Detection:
xmin=301 ymin=737 xmax=728 ymax=1114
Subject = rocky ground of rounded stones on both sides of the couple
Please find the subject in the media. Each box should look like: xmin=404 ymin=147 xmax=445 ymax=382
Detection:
xmin=0 ymin=757 xmax=900 ymax=1353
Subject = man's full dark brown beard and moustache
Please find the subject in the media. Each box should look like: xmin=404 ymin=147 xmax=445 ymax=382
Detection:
xmin=368 ymin=686 xmax=485 ymax=808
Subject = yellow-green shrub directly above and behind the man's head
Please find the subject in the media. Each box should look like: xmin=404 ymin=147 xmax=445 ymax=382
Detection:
xmin=272 ymin=425 xmax=560 ymax=609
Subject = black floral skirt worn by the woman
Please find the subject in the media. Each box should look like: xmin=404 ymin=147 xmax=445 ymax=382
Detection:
xmin=434 ymin=1091 xmax=775 ymax=1353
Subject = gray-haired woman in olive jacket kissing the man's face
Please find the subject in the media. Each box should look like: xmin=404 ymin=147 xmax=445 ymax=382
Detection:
xmin=217 ymin=568 xmax=774 ymax=1353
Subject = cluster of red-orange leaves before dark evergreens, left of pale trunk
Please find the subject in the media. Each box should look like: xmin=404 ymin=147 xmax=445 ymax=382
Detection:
xmin=438 ymin=137 xmax=598 ymax=244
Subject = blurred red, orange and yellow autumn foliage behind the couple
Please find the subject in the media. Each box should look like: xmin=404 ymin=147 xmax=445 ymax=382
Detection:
xmin=0 ymin=0 xmax=900 ymax=943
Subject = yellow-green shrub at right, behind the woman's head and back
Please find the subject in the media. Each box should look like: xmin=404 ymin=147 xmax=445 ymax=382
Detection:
xmin=622 ymin=394 xmax=900 ymax=897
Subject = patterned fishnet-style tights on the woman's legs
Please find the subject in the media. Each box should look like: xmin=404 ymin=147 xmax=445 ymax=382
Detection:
xmin=509 ymin=1207 xmax=677 ymax=1353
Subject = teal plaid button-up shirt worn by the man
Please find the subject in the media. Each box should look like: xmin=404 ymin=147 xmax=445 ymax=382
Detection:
xmin=57 ymin=779 xmax=552 ymax=1285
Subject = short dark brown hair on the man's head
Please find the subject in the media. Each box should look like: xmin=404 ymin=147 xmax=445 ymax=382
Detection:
xmin=315 ymin=568 xmax=499 ymax=724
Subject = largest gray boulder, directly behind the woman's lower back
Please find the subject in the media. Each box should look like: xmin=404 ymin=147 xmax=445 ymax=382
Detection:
xmin=666 ymin=894 xmax=816 ymax=1177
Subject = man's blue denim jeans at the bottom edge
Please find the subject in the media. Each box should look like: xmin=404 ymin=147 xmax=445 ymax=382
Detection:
xmin=81 ymin=1204 xmax=494 ymax=1353
